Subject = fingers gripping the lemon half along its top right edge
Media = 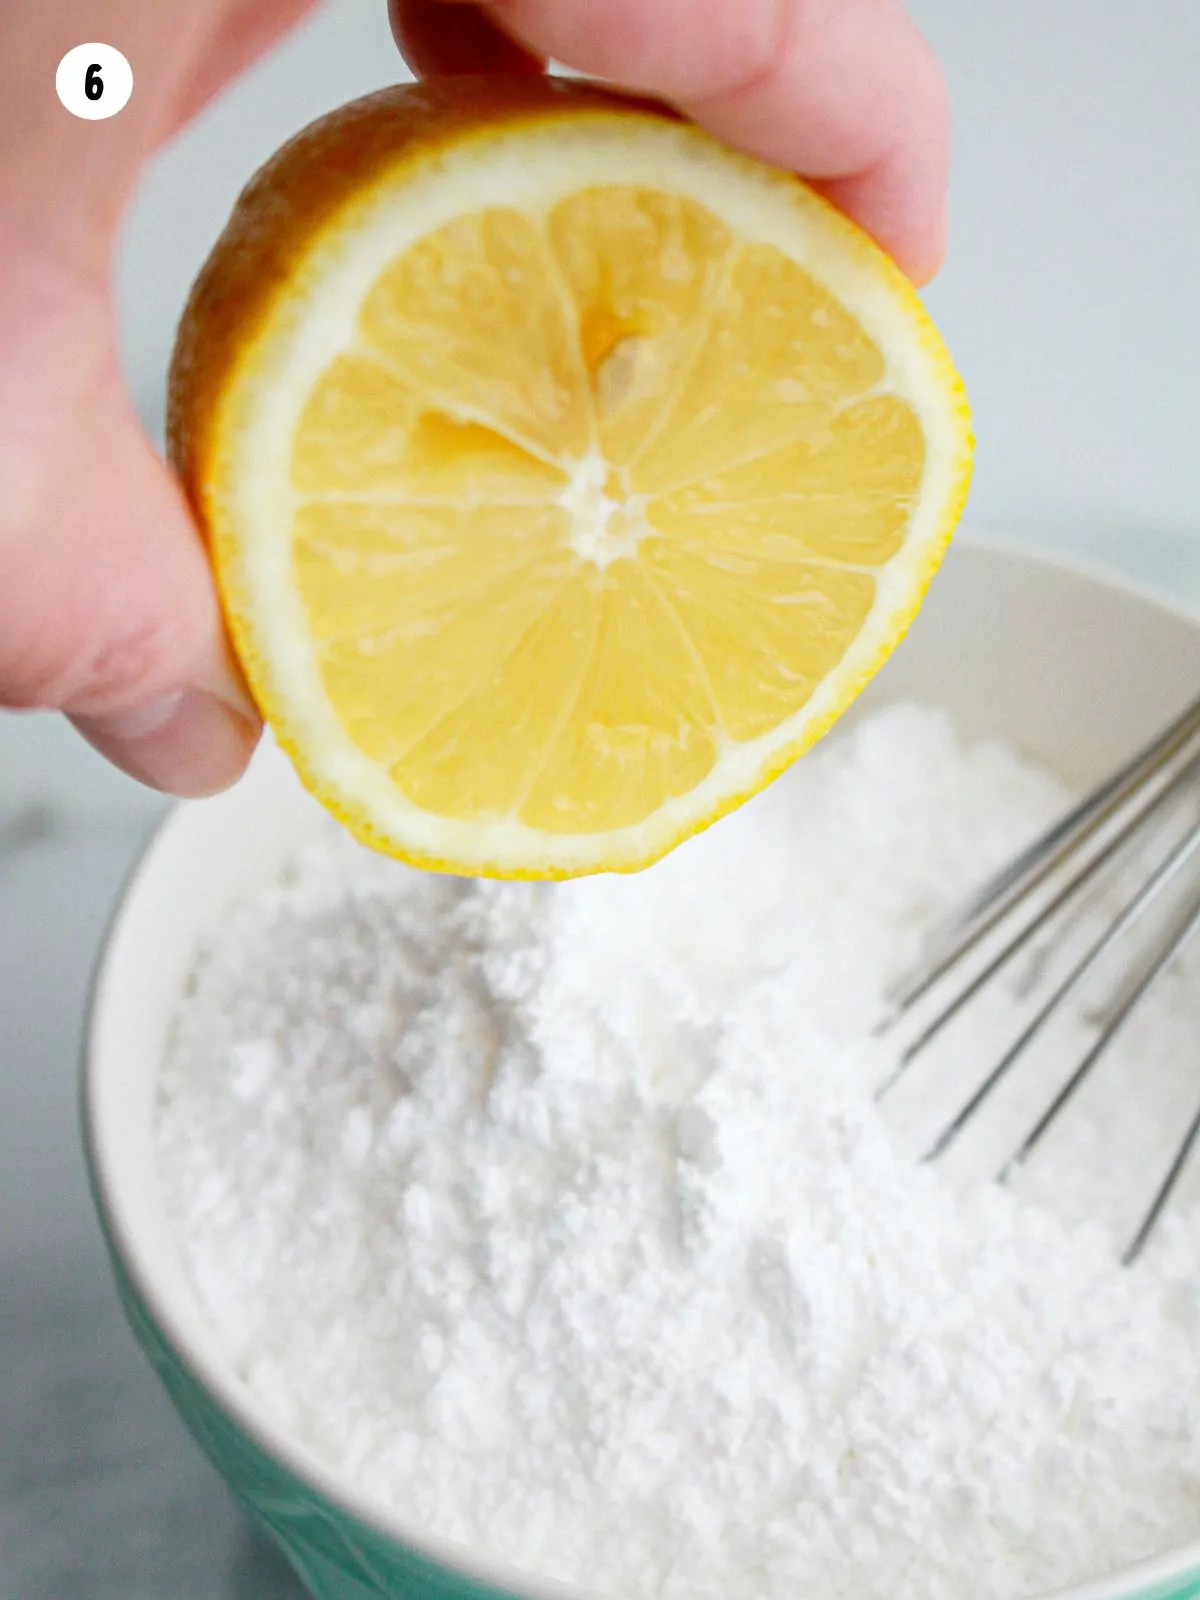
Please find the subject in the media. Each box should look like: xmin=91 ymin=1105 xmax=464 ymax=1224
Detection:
xmin=398 ymin=0 xmax=949 ymax=283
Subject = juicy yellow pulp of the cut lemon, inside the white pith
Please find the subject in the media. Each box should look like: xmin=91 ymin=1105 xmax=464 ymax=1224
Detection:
xmin=293 ymin=184 xmax=923 ymax=834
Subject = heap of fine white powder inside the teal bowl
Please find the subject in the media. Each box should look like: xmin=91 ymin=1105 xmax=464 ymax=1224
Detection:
xmin=160 ymin=707 xmax=1200 ymax=1600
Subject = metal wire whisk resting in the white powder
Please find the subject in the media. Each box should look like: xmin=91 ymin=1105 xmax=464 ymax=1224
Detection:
xmin=877 ymin=698 xmax=1200 ymax=1266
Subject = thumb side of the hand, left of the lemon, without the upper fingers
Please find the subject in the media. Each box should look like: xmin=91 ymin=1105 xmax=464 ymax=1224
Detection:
xmin=0 ymin=0 xmax=309 ymax=795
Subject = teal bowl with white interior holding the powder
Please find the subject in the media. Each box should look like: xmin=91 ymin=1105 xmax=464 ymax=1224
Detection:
xmin=83 ymin=542 xmax=1200 ymax=1600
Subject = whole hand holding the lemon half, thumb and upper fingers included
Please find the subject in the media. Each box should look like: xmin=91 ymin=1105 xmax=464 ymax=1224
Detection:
xmin=0 ymin=0 xmax=947 ymax=795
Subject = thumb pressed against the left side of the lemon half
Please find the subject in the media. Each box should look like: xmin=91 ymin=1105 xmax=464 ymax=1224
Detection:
xmin=0 ymin=261 xmax=261 ymax=795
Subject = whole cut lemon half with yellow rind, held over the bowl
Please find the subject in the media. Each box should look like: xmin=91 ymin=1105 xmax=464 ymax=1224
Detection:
xmin=170 ymin=80 xmax=971 ymax=877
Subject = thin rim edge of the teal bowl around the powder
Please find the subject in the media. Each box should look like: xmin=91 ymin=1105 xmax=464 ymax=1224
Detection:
xmin=80 ymin=536 xmax=1200 ymax=1600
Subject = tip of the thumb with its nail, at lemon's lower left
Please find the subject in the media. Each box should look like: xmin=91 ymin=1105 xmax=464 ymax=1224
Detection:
xmin=70 ymin=690 xmax=261 ymax=798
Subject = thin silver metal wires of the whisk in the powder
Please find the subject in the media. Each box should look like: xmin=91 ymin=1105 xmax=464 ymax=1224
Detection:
xmin=875 ymin=698 xmax=1200 ymax=1266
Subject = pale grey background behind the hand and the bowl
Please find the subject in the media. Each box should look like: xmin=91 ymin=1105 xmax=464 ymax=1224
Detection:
xmin=0 ymin=0 xmax=1200 ymax=1600
